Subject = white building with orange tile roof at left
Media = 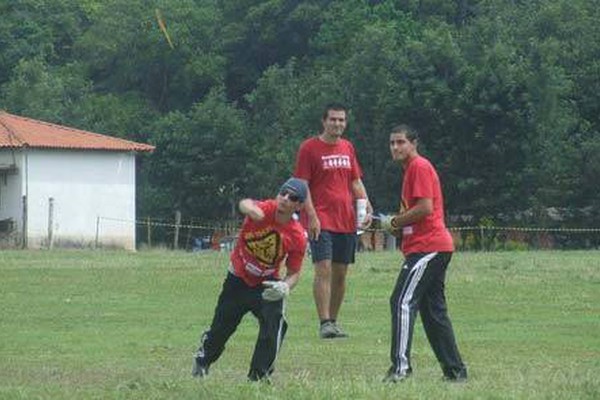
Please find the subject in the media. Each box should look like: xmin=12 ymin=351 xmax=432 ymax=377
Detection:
xmin=0 ymin=110 xmax=154 ymax=250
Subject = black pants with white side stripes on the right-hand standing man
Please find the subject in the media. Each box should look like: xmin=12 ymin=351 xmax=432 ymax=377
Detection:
xmin=390 ymin=252 xmax=466 ymax=379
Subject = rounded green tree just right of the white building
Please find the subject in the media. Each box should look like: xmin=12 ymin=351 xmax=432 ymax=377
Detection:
xmin=141 ymin=89 xmax=250 ymax=220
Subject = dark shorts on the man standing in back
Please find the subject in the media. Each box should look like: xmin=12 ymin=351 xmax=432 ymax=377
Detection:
xmin=310 ymin=231 xmax=356 ymax=264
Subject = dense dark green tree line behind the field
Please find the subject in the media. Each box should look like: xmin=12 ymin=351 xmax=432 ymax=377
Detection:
xmin=0 ymin=0 xmax=600 ymax=230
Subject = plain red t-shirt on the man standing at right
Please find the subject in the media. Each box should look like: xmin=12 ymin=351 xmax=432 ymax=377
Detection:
xmin=402 ymin=156 xmax=454 ymax=254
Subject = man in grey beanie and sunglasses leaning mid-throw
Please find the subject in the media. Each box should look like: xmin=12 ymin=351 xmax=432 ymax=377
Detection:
xmin=192 ymin=178 xmax=308 ymax=381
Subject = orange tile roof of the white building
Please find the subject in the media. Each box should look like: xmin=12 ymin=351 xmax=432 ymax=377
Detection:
xmin=0 ymin=110 xmax=154 ymax=151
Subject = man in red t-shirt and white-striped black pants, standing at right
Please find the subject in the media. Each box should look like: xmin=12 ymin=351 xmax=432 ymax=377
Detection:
xmin=381 ymin=125 xmax=467 ymax=382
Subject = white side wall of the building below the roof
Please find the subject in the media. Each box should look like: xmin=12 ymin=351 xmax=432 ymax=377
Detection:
xmin=20 ymin=149 xmax=135 ymax=250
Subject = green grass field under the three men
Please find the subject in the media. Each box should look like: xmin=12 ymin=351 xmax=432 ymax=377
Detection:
xmin=0 ymin=251 xmax=600 ymax=400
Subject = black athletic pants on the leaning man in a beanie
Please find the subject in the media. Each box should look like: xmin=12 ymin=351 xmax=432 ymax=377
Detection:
xmin=196 ymin=272 xmax=287 ymax=380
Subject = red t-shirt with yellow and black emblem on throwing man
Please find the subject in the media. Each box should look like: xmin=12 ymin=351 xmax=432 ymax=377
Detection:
xmin=231 ymin=199 xmax=307 ymax=287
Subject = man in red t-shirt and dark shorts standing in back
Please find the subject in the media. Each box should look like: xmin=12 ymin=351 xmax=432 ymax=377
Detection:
xmin=294 ymin=104 xmax=372 ymax=339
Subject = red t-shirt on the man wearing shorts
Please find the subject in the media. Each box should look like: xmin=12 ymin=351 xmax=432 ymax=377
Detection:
xmin=294 ymin=137 xmax=362 ymax=233
